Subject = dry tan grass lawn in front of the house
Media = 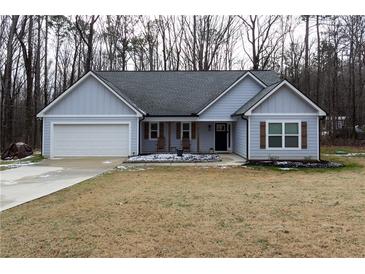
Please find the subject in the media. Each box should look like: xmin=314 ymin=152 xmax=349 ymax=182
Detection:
xmin=0 ymin=158 xmax=365 ymax=257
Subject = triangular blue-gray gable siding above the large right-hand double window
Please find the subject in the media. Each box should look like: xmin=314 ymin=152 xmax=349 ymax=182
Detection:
xmin=252 ymin=85 xmax=317 ymax=113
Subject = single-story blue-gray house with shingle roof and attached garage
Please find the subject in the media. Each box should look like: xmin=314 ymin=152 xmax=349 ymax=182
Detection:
xmin=38 ymin=71 xmax=326 ymax=160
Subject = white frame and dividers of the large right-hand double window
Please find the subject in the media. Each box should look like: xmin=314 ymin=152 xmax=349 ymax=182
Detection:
xmin=265 ymin=120 xmax=302 ymax=150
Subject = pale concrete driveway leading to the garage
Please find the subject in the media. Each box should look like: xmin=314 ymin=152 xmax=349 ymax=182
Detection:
xmin=0 ymin=157 xmax=125 ymax=211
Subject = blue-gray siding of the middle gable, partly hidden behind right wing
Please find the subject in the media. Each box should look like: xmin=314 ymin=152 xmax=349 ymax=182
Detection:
xmin=200 ymin=76 xmax=262 ymax=121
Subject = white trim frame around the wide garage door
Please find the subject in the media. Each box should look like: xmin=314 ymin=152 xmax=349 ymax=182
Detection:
xmin=49 ymin=121 xmax=132 ymax=158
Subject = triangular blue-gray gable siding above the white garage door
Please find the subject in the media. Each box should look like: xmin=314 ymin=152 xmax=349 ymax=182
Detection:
xmin=46 ymin=75 xmax=136 ymax=115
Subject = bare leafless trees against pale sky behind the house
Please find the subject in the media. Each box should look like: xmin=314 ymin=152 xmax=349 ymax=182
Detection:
xmin=0 ymin=15 xmax=365 ymax=150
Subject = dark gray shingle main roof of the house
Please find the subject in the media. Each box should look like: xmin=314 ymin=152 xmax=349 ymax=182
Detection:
xmin=94 ymin=70 xmax=280 ymax=116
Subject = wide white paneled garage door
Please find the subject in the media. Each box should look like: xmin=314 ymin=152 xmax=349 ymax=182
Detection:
xmin=52 ymin=124 xmax=130 ymax=157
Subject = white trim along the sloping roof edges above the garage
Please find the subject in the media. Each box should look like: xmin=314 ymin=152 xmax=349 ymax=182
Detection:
xmin=37 ymin=71 xmax=145 ymax=117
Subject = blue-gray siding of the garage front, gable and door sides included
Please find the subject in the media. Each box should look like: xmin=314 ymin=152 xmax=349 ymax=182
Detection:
xmin=42 ymin=76 xmax=139 ymax=157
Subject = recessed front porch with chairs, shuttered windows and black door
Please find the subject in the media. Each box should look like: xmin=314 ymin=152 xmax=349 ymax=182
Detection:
xmin=140 ymin=120 xmax=235 ymax=154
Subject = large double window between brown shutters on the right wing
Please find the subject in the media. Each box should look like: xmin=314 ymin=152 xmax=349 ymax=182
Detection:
xmin=267 ymin=122 xmax=300 ymax=149
